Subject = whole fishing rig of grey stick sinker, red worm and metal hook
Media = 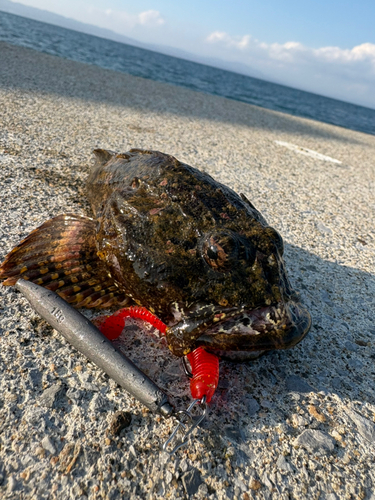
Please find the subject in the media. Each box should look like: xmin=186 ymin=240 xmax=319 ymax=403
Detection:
xmin=15 ymin=279 xmax=219 ymax=455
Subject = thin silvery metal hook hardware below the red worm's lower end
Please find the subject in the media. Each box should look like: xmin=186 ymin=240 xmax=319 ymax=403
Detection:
xmin=162 ymin=396 xmax=207 ymax=456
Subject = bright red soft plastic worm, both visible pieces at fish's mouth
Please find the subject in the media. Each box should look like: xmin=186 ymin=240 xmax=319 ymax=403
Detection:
xmin=94 ymin=306 xmax=219 ymax=403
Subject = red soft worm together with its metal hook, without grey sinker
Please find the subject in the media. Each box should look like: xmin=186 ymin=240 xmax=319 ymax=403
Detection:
xmin=94 ymin=306 xmax=219 ymax=455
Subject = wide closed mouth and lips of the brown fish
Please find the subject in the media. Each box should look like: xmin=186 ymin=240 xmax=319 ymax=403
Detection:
xmin=168 ymin=302 xmax=311 ymax=358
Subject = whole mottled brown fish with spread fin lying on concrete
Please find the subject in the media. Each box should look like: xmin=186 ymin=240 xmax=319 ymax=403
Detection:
xmin=0 ymin=149 xmax=311 ymax=359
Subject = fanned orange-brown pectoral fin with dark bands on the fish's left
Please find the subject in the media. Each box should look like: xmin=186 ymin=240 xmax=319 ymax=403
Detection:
xmin=0 ymin=214 xmax=129 ymax=308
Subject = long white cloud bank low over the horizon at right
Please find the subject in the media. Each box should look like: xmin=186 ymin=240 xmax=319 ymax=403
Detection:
xmin=205 ymin=31 xmax=375 ymax=107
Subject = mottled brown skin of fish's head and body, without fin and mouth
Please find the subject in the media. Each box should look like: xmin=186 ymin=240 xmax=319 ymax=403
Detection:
xmin=87 ymin=149 xmax=310 ymax=355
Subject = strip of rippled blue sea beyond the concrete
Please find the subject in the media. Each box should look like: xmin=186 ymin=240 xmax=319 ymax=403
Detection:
xmin=0 ymin=12 xmax=375 ymax=135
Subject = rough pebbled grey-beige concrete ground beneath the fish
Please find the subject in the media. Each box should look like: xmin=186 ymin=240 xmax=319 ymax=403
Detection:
xmin=0 ymin=43 xmax=375 ymax=500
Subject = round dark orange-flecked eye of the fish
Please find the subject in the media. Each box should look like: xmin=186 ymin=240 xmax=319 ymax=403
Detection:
xmin=202 ymin=233 xmax=236 ymax=271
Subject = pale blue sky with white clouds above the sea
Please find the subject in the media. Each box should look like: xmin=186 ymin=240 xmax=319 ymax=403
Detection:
xmin=7 ymin=0 xmax=375 ymax=108
